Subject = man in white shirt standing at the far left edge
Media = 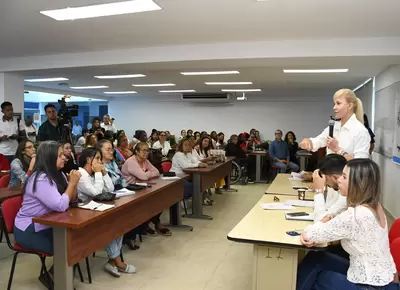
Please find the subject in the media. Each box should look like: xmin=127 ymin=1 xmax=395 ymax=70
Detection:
xmin=0 ymin=102 xmax=26 ymax=163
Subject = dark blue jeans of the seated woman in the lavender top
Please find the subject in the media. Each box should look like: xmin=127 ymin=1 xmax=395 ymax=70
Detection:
xmin=14 ymin=223 xmax=54 ymax=255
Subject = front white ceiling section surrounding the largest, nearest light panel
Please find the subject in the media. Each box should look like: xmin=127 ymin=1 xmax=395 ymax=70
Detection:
xmin=0 ymin=0 xmax=400 ymax=58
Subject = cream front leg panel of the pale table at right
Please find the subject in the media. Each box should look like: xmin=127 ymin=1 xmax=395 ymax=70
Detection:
xmin=252 ymin=245 xmax=298 ymax=290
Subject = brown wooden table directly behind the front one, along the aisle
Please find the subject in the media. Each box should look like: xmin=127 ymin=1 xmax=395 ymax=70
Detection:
xmin=183 ymin=157 xmax=235 ymax=220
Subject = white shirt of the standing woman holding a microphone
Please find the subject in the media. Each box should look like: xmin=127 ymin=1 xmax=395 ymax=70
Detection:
xmin=310 ymin=114 xmax=371 ymax=158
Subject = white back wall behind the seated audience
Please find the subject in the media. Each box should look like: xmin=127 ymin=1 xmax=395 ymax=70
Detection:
xmin=109 ymin=92 xmax=333 ymax=140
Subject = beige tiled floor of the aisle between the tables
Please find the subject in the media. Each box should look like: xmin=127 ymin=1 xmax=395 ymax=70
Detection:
xmin=0 ymin=184 xmax=267 ymax=290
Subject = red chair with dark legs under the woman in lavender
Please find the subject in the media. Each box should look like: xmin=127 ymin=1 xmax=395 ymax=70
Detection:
xmin=0 ymin=196 xmax=83 ymax=290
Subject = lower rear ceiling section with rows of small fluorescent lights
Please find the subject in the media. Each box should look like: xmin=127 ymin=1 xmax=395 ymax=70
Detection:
xmin=23 ymin=56 xmax=400 ymax=98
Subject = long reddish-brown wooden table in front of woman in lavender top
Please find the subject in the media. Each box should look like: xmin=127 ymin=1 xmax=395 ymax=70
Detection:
xmin=33 ymin=175 xmax=188 ymax=290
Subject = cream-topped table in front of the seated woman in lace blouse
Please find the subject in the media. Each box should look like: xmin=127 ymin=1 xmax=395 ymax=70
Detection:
xmin=228 ymin=195 xmax=313 ymax=290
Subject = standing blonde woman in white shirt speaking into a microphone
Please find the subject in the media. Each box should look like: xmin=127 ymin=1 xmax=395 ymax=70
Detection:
xmin=300 ymin=89 xmax=370 ymax=160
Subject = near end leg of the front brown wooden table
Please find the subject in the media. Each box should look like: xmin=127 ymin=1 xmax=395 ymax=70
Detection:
xmin=53 ymin=227 xmax=74 ymax=290
